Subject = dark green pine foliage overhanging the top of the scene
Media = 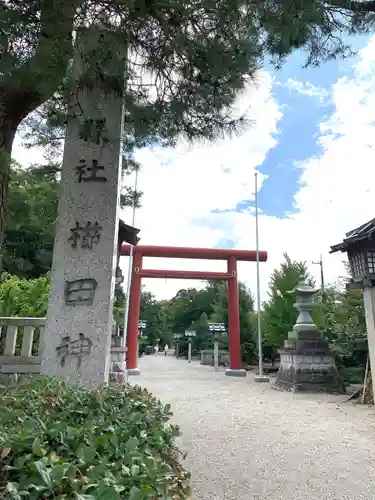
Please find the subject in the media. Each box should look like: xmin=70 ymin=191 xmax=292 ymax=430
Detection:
xmin=0 ymin=0 xmax=375 ymax=146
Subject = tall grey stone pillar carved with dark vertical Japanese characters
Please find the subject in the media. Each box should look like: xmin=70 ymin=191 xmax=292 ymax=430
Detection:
xmin=41 ymin=28 xmax=124 ymax=389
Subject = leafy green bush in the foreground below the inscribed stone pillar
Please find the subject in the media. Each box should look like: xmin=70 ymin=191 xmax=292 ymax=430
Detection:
xmin=0 ymin=377 xmax=189 ymax=500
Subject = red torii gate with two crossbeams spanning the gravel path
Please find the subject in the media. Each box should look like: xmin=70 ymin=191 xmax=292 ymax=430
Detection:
xmin=121 ymin=244 xmax=267 ymax=377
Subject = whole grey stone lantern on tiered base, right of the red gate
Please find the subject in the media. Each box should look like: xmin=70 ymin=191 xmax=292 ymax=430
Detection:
xmin=274 ymin=283 xmax=345 ymax=394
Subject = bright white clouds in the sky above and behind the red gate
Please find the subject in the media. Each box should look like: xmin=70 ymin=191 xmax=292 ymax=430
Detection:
xmin=124 ymin=37 xmax=375 ymax=304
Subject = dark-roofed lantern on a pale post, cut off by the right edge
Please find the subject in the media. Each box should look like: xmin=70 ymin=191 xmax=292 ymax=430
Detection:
xmin=330 ymin=219 xmax=375 ymax=384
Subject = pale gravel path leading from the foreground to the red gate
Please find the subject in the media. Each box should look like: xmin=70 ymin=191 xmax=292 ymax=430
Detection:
xmin=137 ymin=356 xmax=375 ymax=500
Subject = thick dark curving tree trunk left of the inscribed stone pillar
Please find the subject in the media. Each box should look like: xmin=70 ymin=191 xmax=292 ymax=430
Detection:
xmin=0 ymin=0 xmax=83 ymax=271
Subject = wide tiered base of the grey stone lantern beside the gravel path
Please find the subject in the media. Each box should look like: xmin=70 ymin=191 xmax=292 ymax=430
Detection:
xmin=273 ymin=351 xmax=345 ymax=394
